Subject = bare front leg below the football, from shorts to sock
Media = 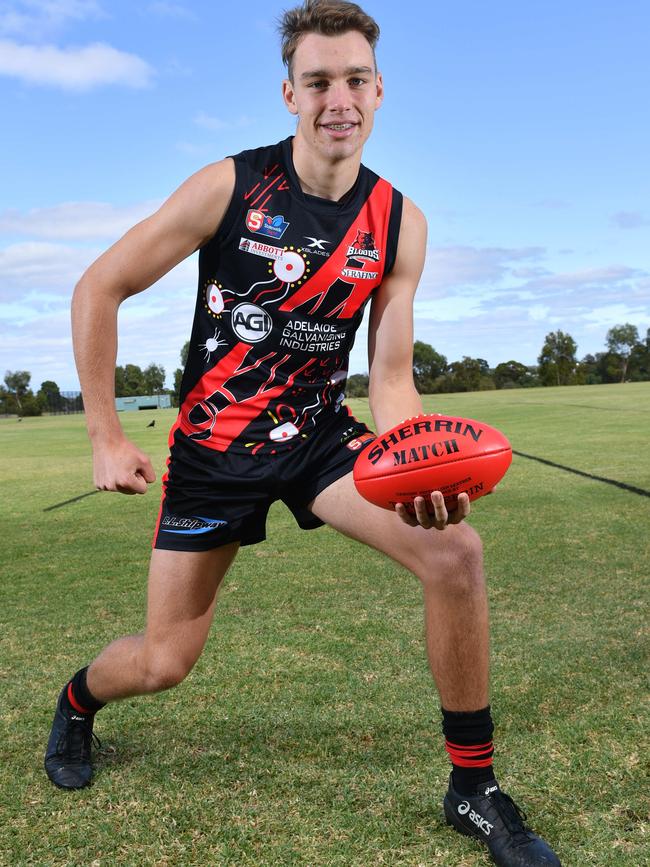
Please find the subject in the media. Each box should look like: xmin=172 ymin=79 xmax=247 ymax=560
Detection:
xmin=310 ymin=474 xmax=489 ymax=711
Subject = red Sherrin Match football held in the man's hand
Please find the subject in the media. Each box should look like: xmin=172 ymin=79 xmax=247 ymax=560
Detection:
xmin=353 ymin=414 xmax=512 ymax=511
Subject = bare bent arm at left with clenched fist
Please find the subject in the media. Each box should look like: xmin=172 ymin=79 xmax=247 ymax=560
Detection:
xmin=72 ymin=160 xmax=235 ymax=493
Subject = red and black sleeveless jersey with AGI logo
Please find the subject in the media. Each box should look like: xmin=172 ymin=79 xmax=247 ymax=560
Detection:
xmin=178 ymin=138 xmax=402 ymax=454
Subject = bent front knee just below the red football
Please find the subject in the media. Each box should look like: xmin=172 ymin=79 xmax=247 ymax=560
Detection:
xmin=416 ymin=524 xmax=485 ymax=595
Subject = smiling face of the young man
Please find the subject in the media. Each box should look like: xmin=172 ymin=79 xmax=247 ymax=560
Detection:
xmin=282 ymin=31 xmax=384 ymax=160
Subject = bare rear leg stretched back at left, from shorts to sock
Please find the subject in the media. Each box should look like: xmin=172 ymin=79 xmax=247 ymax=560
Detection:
xmin=87 ymin=542 xmax=239 ymax=702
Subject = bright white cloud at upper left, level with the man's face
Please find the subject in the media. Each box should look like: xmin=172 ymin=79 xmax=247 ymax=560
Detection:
xmin=0 ymin=40 xmax=153 ymax=91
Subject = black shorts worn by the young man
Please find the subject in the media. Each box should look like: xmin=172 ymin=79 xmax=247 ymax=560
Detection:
xmin=153 ymin=407 xmax=375 ymax=551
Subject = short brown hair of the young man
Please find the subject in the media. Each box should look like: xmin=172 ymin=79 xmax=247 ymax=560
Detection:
xmin=278 ymin=0 xmax=379 ymax=80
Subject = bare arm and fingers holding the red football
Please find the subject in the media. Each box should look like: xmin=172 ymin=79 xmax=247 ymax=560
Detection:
xmin=368 ymin=198 xmax=470 ymax=530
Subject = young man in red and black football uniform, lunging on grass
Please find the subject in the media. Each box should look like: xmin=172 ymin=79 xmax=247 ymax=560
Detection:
xmin=45 ymin=0 xmax=559 ymax=867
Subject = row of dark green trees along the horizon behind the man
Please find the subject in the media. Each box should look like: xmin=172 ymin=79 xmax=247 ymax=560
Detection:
xmin=0 ymin=322 xmax=650 ymax=416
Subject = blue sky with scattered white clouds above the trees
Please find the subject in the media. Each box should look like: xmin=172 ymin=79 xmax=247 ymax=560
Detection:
xmin=0 ymin=0 xmax=650 ymax=389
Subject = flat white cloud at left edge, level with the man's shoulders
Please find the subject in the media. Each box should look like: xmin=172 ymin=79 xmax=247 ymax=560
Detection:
xmin=0 ymin=201 xmax=161 ymax=241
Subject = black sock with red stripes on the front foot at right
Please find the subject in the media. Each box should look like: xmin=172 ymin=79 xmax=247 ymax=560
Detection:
xmin=441 ymin=705 xmax=494 ymax=795
